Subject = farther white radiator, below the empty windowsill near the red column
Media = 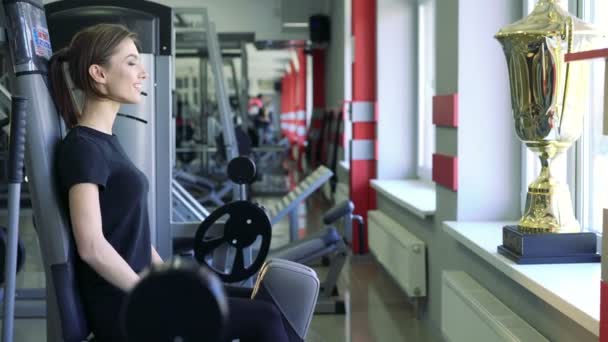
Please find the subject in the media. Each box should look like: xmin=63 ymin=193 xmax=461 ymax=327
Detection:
xmin=367 ymin=210 xmax=426 ymax=297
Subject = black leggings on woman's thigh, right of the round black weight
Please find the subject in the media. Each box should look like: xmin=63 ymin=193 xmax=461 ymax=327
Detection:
xmin=226 ymin=286 xmax=289 ymax=342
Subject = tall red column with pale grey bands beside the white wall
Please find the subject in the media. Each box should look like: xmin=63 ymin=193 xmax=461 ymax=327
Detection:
xmin=350 ymin=0 xmax=376 ymax=254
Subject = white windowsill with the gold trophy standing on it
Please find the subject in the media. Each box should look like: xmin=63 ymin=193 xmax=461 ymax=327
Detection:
xmin=443 ymin=222 xmax=601 ymax=336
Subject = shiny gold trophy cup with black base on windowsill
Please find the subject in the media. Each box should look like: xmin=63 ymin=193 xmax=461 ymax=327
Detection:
xmin=495 ymin=0 xmax=600 ymax=263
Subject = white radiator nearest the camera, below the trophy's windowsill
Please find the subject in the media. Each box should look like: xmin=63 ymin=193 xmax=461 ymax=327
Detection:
xmin=441 ymin=271 xmax=548 ymax=342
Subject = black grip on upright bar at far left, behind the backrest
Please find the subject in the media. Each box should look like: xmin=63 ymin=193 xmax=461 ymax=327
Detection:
xmin=8 ymin=96 xmax=27 ymax=184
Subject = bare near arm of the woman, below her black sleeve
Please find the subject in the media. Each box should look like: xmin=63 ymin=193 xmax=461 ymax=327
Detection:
xmin=69 ymin=183 xmax=139 ymax=291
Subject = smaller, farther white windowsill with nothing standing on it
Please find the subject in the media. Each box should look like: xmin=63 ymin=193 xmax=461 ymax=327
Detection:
xmin=371 ymin=179 xmax=436 ymax=219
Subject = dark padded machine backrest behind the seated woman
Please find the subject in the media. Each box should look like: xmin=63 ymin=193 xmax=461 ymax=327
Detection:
xmin=5 ymin=0 xmax=89 ymax=342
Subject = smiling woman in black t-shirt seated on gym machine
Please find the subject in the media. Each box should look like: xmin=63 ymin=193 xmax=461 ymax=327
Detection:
xmin=49 ymin=24 xmax=288 ymax=342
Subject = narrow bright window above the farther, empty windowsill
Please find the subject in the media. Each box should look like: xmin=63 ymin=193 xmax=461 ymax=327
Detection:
xmin=417 ymin=0 xmax=435 ymax=181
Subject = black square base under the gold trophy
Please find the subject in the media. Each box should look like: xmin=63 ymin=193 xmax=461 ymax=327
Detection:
xmin=498 ymin=226 xmax=601 ymax=264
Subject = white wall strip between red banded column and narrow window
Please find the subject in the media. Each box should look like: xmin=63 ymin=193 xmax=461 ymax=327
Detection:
xmin=376 ymin=0 xmax=417 ymax=179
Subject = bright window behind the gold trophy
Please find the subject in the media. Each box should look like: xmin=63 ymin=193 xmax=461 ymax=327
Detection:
xmin=522 ymin=0 xmax=608 ymax=232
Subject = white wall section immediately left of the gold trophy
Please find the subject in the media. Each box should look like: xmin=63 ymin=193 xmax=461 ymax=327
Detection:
xmin=458 ymin=0 xmax=522 ymax=220
